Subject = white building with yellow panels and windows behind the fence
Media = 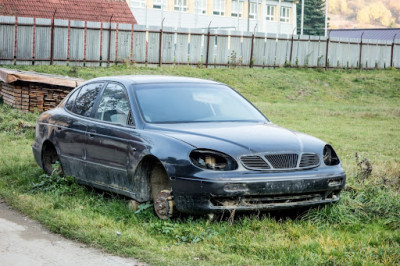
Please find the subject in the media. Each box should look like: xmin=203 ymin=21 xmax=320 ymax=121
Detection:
xmin=127 ymin=0 xmax=297 ymax=34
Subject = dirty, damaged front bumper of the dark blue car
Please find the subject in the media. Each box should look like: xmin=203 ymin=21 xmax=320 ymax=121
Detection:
xmin=171 ymin=167 xmax=346 ymax=214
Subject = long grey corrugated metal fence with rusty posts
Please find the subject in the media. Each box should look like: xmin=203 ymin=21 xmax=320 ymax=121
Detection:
xmin=0 ymin=16 xmax=400 ymax=69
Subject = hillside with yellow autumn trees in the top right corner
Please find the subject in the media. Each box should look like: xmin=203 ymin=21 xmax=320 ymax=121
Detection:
xmin=329 ymin=0 xmax=400 ymax=29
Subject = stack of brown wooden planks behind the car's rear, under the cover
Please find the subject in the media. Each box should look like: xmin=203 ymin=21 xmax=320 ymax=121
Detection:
xmin=0 ymin=82 xmax=73 ymax=112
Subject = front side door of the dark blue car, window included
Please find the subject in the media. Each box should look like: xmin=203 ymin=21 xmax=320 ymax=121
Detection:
xmin=86 ymin=82 xmax=136 ymax=193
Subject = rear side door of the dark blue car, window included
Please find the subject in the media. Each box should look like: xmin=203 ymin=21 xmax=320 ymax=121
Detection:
xmin=55 ymin=82 xmax=104 ymax=180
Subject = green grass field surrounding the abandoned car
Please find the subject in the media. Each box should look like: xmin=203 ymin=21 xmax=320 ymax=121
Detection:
xmin=0 ymin=66 xmax=400 ymax=265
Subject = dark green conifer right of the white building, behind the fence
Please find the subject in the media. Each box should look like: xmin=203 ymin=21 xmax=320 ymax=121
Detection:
xmin=297 ymin=0 xmax=325 ymax=36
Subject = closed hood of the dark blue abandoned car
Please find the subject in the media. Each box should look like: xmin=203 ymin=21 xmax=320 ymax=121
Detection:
xmin=145 ymin=123 xmax=324 ymax=154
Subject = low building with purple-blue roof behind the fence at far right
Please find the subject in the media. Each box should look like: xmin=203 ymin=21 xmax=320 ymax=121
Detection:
xmin=329 ymin=28 xmax=400 ymax=41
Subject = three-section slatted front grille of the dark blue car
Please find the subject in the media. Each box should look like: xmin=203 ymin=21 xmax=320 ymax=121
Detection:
xmin=240 ymin=153 xmax=319 ymax=171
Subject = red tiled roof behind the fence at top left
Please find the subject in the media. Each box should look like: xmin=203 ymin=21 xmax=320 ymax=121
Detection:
xmin=0 ymin=0 xmax=137 ymax=24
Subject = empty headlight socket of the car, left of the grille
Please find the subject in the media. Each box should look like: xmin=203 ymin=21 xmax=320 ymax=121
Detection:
xmin=189 ymin=149 xmax=238 ymax=171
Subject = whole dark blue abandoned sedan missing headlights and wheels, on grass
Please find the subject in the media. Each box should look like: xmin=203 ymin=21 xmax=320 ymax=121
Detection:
xmin=32 ymin=76 xmax=346 ymax=219
